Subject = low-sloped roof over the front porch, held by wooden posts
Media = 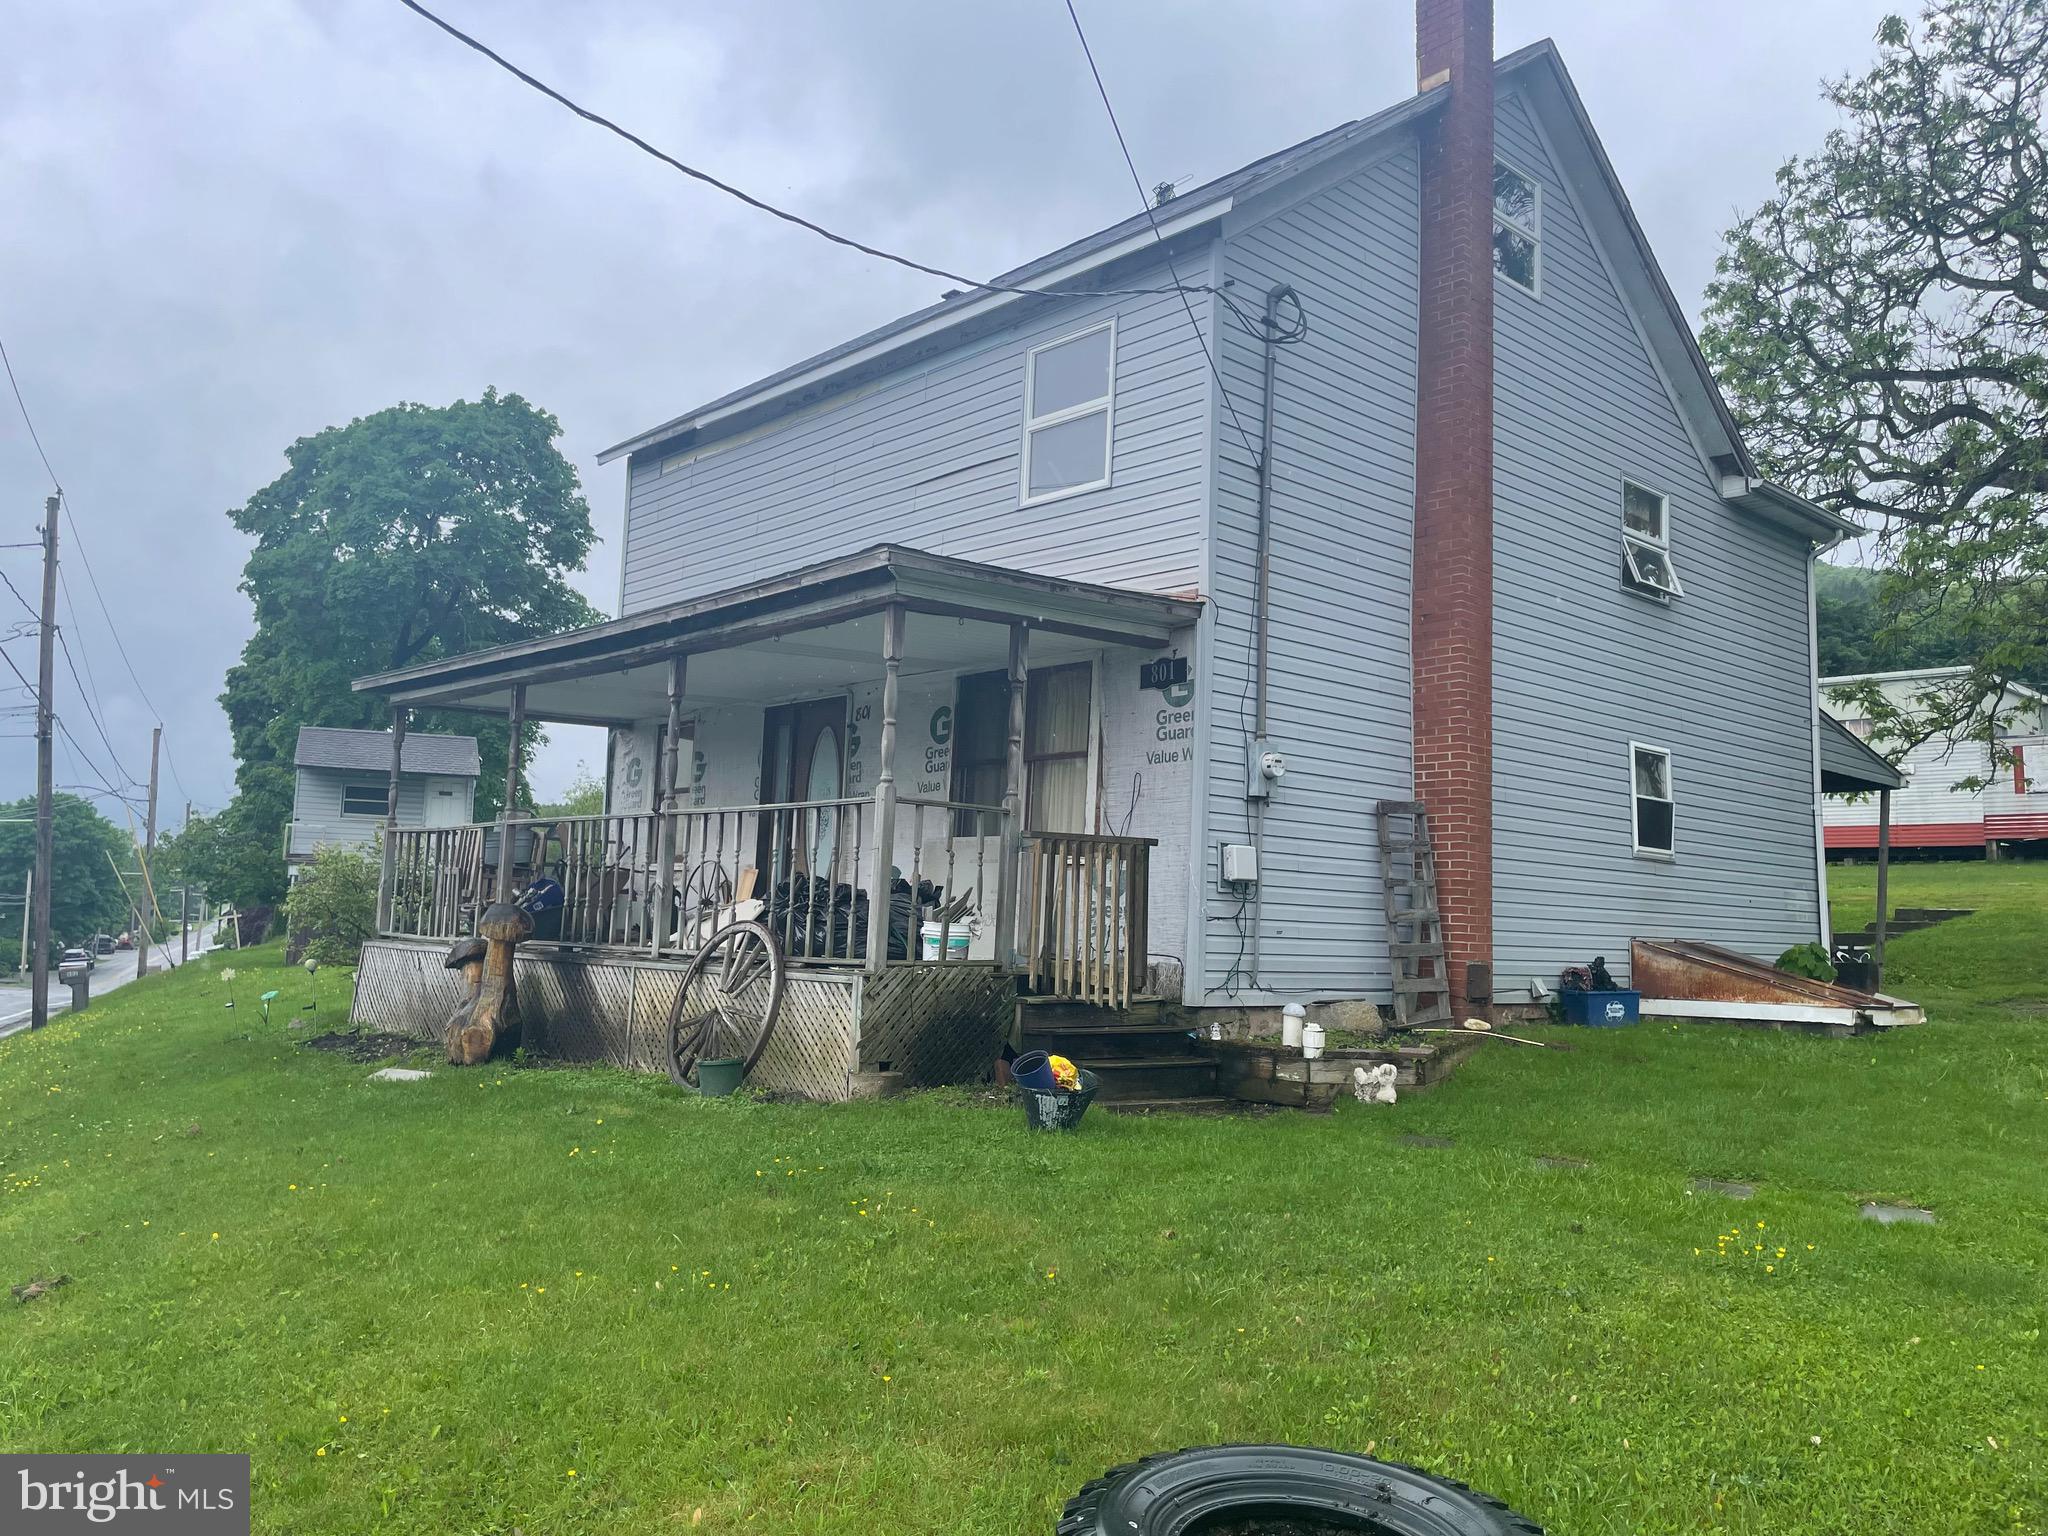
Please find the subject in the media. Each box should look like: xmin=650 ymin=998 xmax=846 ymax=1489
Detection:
xmin=354 ymin=545 xmax=1202 ymax=725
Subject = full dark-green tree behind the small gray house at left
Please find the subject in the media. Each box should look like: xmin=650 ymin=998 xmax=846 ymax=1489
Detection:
xmin=209 ymin=389 xmax=600 ymax=905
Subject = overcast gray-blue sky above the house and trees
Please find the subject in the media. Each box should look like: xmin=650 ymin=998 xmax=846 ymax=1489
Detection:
xmin=0 ymin=0 xmax=1898 ymax=821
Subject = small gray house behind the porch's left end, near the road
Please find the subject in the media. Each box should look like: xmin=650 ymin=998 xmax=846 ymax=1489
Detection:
xmin=285 ymin=725 xmax=477 ymax=879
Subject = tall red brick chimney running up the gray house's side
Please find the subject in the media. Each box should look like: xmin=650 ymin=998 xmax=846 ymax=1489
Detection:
xmin=1409 ymin=0 xmax=1493 ymax=1018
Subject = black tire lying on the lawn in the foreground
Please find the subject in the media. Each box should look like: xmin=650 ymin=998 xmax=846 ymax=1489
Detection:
xmin=1059 ymin=1446 xmax=1542 ymax=1536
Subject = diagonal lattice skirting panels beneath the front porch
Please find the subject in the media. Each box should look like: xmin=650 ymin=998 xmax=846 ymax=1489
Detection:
xmin=348 ymin=938 xmax=1014 ymax=1100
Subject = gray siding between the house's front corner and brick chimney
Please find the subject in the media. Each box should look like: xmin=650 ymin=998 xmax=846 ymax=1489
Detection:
xmin=1190 ymin=143 xmax=1419 ymax=1004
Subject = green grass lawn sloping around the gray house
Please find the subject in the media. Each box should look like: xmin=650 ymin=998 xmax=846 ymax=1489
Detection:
xmin=0 ymin=864 xmax=2048 ymax=1536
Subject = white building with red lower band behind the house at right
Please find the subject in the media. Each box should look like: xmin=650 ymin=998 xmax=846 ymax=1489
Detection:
xmin=1821 ymin=668 xmax=2048 ymax=858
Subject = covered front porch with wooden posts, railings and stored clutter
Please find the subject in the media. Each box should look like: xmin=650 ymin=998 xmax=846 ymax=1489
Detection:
xmin=356 ymin=547 xmax=1198 ymax=1097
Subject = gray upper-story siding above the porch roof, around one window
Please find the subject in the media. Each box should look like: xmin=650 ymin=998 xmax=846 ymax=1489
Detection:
xmin=621 ymin=266 xmax=1206 ymax=612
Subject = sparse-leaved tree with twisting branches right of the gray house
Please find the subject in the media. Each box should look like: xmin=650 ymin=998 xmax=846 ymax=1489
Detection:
xmin=1700 ymin=0 xmax=2048 ymax=758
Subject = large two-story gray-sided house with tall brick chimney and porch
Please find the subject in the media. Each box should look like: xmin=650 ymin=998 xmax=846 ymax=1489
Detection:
xmin=356 ymin=0 xmax=1849 ymax=1097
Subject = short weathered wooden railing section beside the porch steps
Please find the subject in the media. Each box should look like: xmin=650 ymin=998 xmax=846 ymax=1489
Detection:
xmin=1024 ymin=831 xmax=1157 ymax=1008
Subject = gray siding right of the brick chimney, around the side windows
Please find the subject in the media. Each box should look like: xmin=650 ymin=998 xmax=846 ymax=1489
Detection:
xmin=1493 ymin=96 xmax=1819 ymax=987
